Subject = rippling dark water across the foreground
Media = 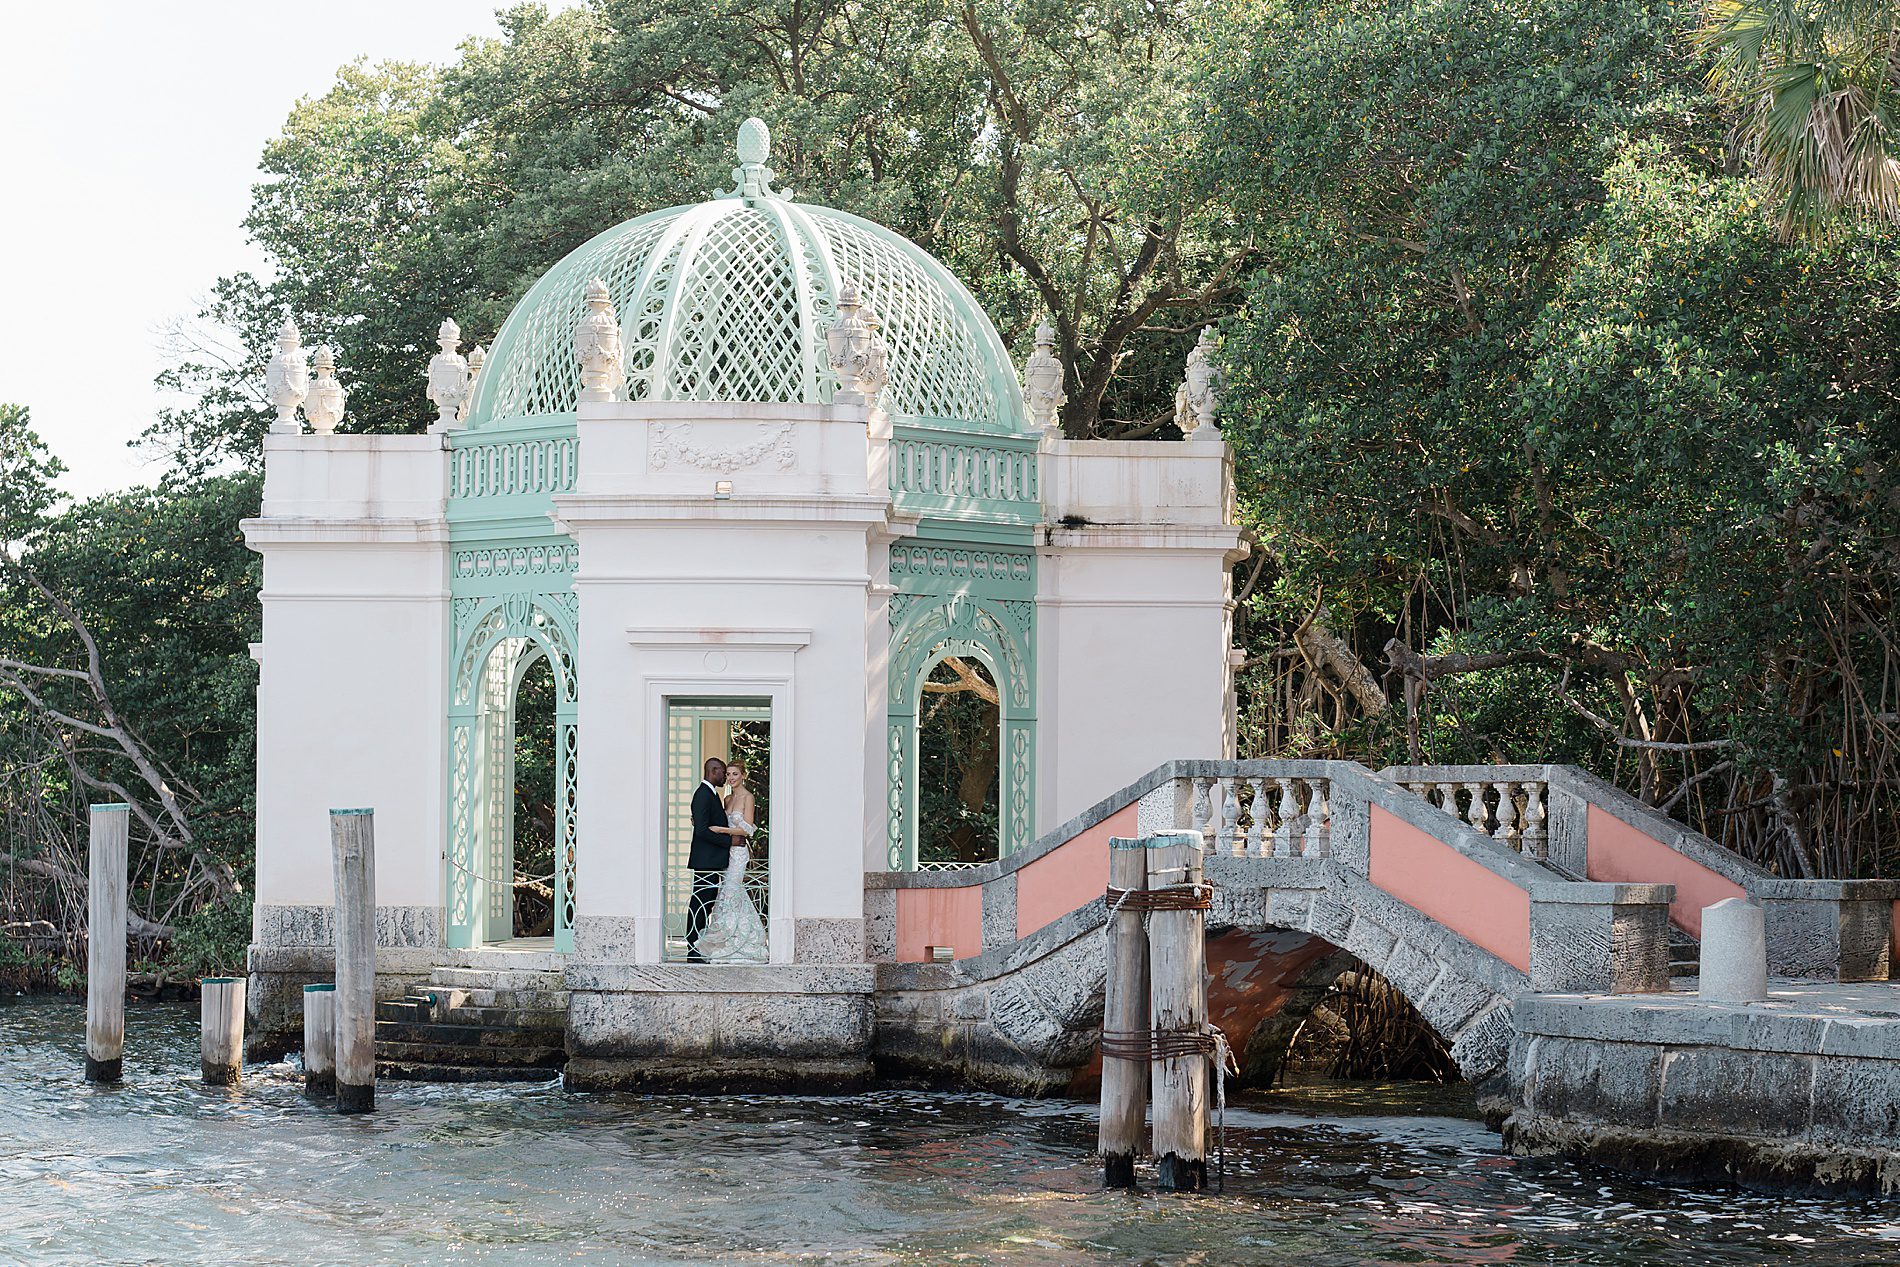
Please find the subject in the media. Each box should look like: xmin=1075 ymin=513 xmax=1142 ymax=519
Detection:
xmin=0 ymin=1003 xmax=1900 ymax=1267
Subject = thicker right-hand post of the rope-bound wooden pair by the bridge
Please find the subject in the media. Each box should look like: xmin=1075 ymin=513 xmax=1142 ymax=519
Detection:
xmin=1148 ymin=832 xmax=1208 ymax=1193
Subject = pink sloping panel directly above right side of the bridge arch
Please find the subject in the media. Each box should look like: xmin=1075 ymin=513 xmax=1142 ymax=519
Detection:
xmin=1368 ymin=805 xmax=1531 ymax=973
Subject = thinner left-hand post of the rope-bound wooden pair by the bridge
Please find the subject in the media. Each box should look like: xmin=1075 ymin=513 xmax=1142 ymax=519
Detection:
xmin=1100 ymin=836 xmax=1150 ymax=1187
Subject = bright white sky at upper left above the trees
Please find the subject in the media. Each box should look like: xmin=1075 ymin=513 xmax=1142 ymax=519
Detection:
xmin=0 ymin=0 xmax=564 ymax=496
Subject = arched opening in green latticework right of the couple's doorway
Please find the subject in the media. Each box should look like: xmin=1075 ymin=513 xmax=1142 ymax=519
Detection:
xmin=916 ymin=653 xmax=1003 ymax=868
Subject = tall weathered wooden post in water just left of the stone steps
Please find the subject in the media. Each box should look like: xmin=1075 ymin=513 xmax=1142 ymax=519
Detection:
xmin=331 ymin=809 xmax=376 ymax=1113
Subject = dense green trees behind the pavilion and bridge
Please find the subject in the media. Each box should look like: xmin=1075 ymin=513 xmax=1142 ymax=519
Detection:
xmin=0 ymin=0 xmax=1900 ymax=969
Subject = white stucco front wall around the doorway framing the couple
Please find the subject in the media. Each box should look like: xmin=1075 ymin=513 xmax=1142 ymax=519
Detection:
xmin=555 ymin=403 xmax=889 ymax=963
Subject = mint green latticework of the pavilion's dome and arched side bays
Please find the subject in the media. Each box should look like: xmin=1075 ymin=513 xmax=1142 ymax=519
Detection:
xmin=447 ymin=120 xmax=1041 ymax=896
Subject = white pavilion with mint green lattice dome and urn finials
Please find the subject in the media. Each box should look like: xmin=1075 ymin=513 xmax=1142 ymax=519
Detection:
xmin=245 ymin=120 xmax=1245 ymax=1060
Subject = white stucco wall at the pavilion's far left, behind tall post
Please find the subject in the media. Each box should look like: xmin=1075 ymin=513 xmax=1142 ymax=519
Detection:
xmin=245 ymin=435 xmax=448 ymax=923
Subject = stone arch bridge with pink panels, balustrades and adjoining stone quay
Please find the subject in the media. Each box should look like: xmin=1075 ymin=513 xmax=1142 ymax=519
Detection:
xmin=866 ymin=762 xmax=1900 ymax=1189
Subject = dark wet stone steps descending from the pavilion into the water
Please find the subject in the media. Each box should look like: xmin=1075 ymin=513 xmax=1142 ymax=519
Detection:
xmin=376 ymin=950 xmax=568 ymax=1083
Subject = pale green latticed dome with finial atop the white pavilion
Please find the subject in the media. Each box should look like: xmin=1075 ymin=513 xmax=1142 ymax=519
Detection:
xmin=467 ymin=120 xmax=1024 ymax=433
